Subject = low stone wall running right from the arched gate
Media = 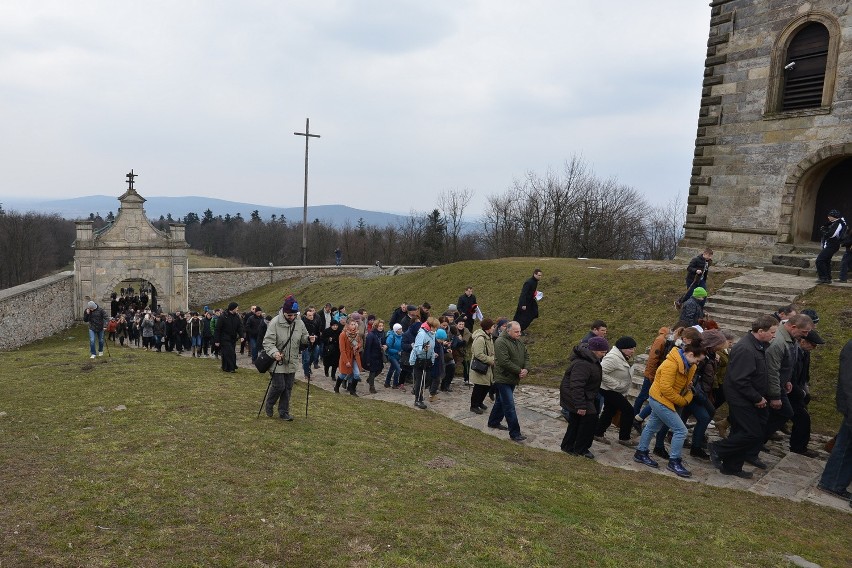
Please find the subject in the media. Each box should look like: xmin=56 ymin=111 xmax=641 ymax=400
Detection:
xmin=189 ymin=265 xmax=422 ymax=306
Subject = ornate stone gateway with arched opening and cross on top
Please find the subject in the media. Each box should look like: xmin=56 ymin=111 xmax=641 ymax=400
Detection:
xmin=74 ymin=171 xmax=189 ymax=317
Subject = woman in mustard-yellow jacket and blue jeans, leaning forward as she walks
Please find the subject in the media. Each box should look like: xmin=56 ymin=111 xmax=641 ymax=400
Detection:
xmin=633 ymin=340 xmax=704 ymax=477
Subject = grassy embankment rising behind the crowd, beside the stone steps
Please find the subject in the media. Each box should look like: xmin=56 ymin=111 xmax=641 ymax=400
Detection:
xmin=221 ymin=258 xmax=852 ymax=434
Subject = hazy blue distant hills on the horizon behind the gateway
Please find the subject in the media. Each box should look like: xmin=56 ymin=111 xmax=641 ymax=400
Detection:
xmin=0 ymin=195 xmax=406 ymax=227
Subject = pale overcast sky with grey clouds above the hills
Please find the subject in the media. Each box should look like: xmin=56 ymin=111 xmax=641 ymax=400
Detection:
xmin=0 ymin=0 xmax=710 ymax=214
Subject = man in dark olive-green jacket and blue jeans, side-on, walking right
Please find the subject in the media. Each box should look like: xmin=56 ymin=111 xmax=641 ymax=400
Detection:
xmin=488 ymin=321 xmax=530 ymax=442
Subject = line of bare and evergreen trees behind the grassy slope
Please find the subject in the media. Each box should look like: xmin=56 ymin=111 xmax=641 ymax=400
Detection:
xmin=0 ymin=157 xmax=686 ymax=287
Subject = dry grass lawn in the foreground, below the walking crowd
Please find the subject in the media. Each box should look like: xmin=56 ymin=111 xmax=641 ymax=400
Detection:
xmin=0 ymin=328 xmax=852 ymax=567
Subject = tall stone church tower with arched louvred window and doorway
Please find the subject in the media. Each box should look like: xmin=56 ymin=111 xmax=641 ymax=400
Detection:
xmin=678 ymin=0 xmax=852 ymax=265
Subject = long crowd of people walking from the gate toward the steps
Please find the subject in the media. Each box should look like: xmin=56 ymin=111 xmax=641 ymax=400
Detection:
xmin=85 ymin=249 xmax=852 ymax=506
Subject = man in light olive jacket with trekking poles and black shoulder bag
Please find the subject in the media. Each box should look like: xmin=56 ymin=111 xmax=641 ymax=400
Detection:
xmin=263 ymin=295 xmax=316 ymax=422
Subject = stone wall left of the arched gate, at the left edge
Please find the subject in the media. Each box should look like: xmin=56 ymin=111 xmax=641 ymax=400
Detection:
xmin=0 ymin=270 xmax=75 ymax=350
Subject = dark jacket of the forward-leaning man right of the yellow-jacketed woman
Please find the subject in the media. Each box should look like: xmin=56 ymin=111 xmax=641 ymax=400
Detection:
xmin=723 ymin=333 xmax=769 ymax=406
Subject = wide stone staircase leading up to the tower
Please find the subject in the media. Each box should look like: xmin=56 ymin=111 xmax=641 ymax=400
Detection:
xmin=628 ymin=268 xmax=820 ymax=400
